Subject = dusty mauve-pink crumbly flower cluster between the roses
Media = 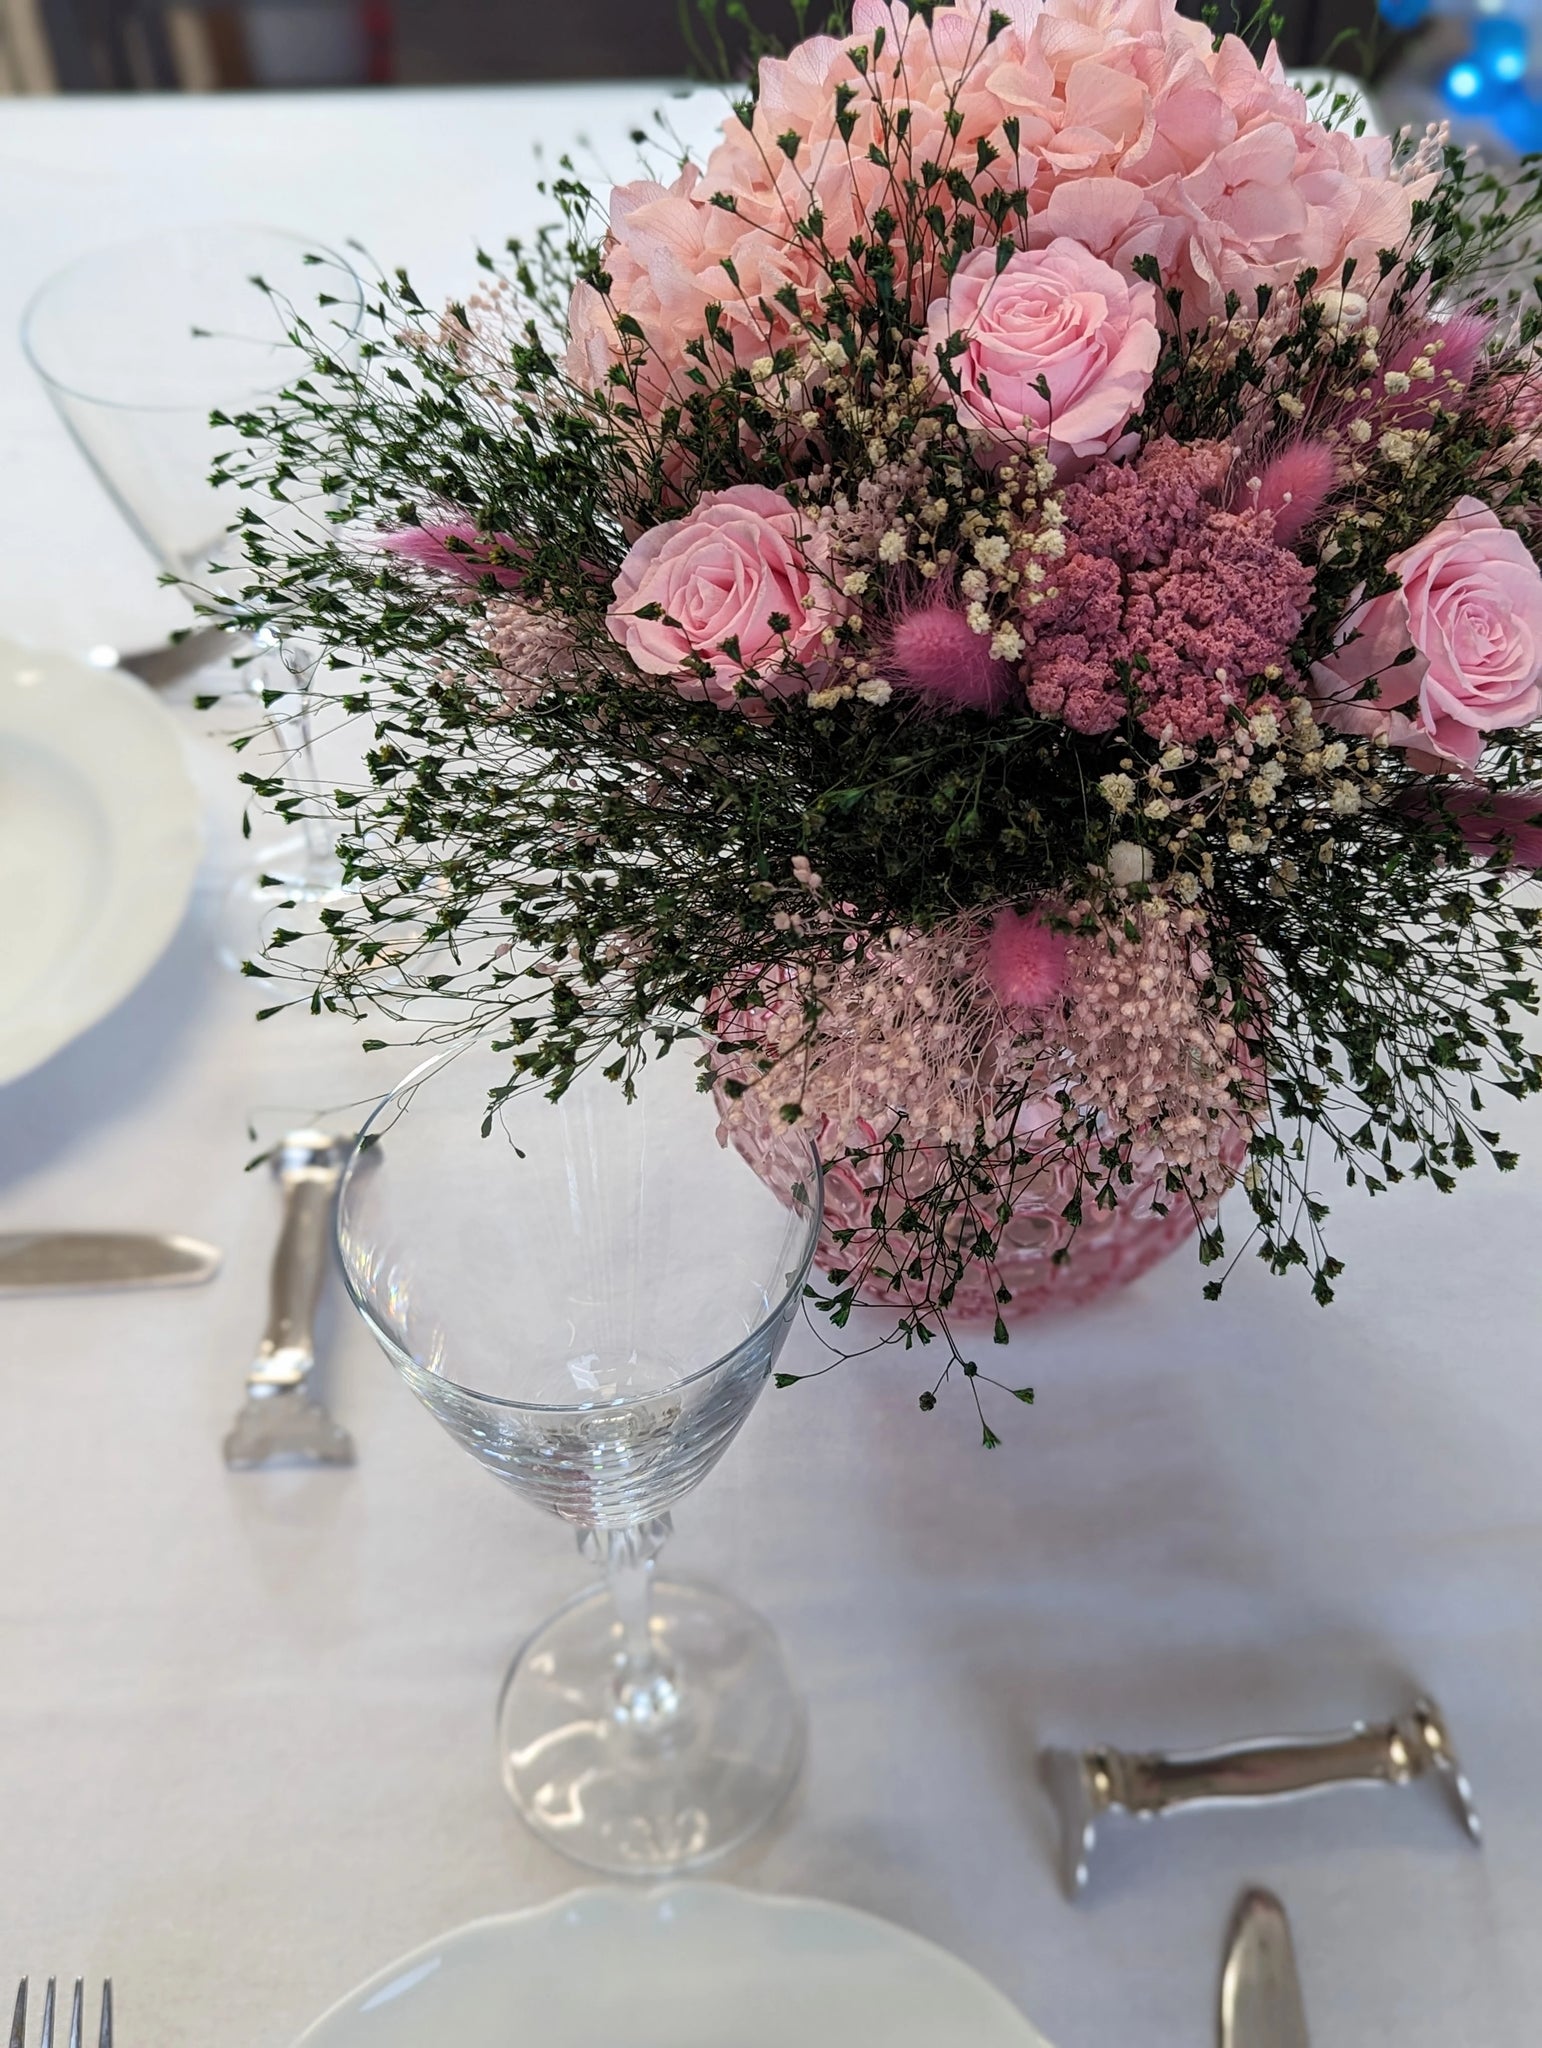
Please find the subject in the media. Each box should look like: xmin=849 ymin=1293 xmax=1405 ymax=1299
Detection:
xmin=1024 ymin=440 xmax=1313 ymax=745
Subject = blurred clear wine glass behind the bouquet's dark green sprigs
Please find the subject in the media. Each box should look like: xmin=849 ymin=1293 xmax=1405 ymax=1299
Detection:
xmin=20 ymin=223 xmax=365 ymax=946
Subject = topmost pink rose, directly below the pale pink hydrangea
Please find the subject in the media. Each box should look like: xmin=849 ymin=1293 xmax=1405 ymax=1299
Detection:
xmin=926 ymin=236 xmax=1161 ymax=471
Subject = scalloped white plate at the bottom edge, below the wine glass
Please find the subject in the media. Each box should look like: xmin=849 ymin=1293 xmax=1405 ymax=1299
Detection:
xmin=297 ymin=1884 xmax=1046 ymax=2048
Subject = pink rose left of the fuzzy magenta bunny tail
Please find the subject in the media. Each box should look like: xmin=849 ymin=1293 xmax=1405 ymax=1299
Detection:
xmin=606 ymin=483 xmax=840 ymax=707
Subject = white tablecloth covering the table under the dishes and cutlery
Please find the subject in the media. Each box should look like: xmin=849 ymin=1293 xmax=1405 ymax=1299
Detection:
xmin=0 ymin=88 xmax=1542 ymax=2048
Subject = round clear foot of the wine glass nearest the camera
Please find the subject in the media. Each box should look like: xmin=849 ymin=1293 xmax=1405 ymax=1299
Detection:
xmin=498 ymin=1579 xmax=803 ymax=1878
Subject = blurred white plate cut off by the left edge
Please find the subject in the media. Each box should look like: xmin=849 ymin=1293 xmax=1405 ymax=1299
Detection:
xmin=0 ymin=641 xmax=201 ymax=1081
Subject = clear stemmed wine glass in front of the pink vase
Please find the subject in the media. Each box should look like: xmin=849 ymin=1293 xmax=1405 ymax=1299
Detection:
xmin=338 ymin=1049 xmax=823 ymax=1876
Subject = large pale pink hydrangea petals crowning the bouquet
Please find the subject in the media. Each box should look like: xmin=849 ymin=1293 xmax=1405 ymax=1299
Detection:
xmin=569 ymin=0 xmax=1419 ymax=408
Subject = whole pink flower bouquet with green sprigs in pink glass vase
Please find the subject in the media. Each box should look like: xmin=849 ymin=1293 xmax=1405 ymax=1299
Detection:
xmin=227 ymin=0 xmax=1542 ymax=1433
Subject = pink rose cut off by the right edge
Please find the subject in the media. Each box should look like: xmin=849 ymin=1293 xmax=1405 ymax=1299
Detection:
xmin=1315 ymin=498 xmax=1542 ymax=768
